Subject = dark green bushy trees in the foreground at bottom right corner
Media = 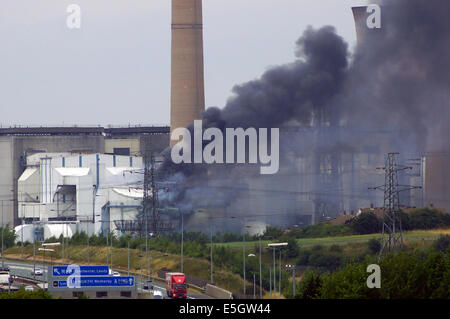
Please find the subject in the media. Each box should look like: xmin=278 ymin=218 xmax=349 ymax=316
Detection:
xmin=292 ymin=235 xmax=450 ymax=299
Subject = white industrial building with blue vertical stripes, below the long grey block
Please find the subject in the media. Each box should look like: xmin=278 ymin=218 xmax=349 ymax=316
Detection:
xmin=16 ymin=153 xmax=143 ymax=242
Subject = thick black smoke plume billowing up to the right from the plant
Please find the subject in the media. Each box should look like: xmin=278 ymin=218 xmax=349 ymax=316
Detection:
xmin=160 ymin=0 xmax=450 ymax=231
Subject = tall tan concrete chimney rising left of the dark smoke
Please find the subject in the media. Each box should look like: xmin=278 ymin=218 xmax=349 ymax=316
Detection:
xmin=170 ymin=0 xmax=205 ymax=145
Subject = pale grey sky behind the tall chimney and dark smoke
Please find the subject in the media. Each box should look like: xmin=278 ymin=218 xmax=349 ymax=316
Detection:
xmin=0 ymin=0 xmax=368 ymax=127
